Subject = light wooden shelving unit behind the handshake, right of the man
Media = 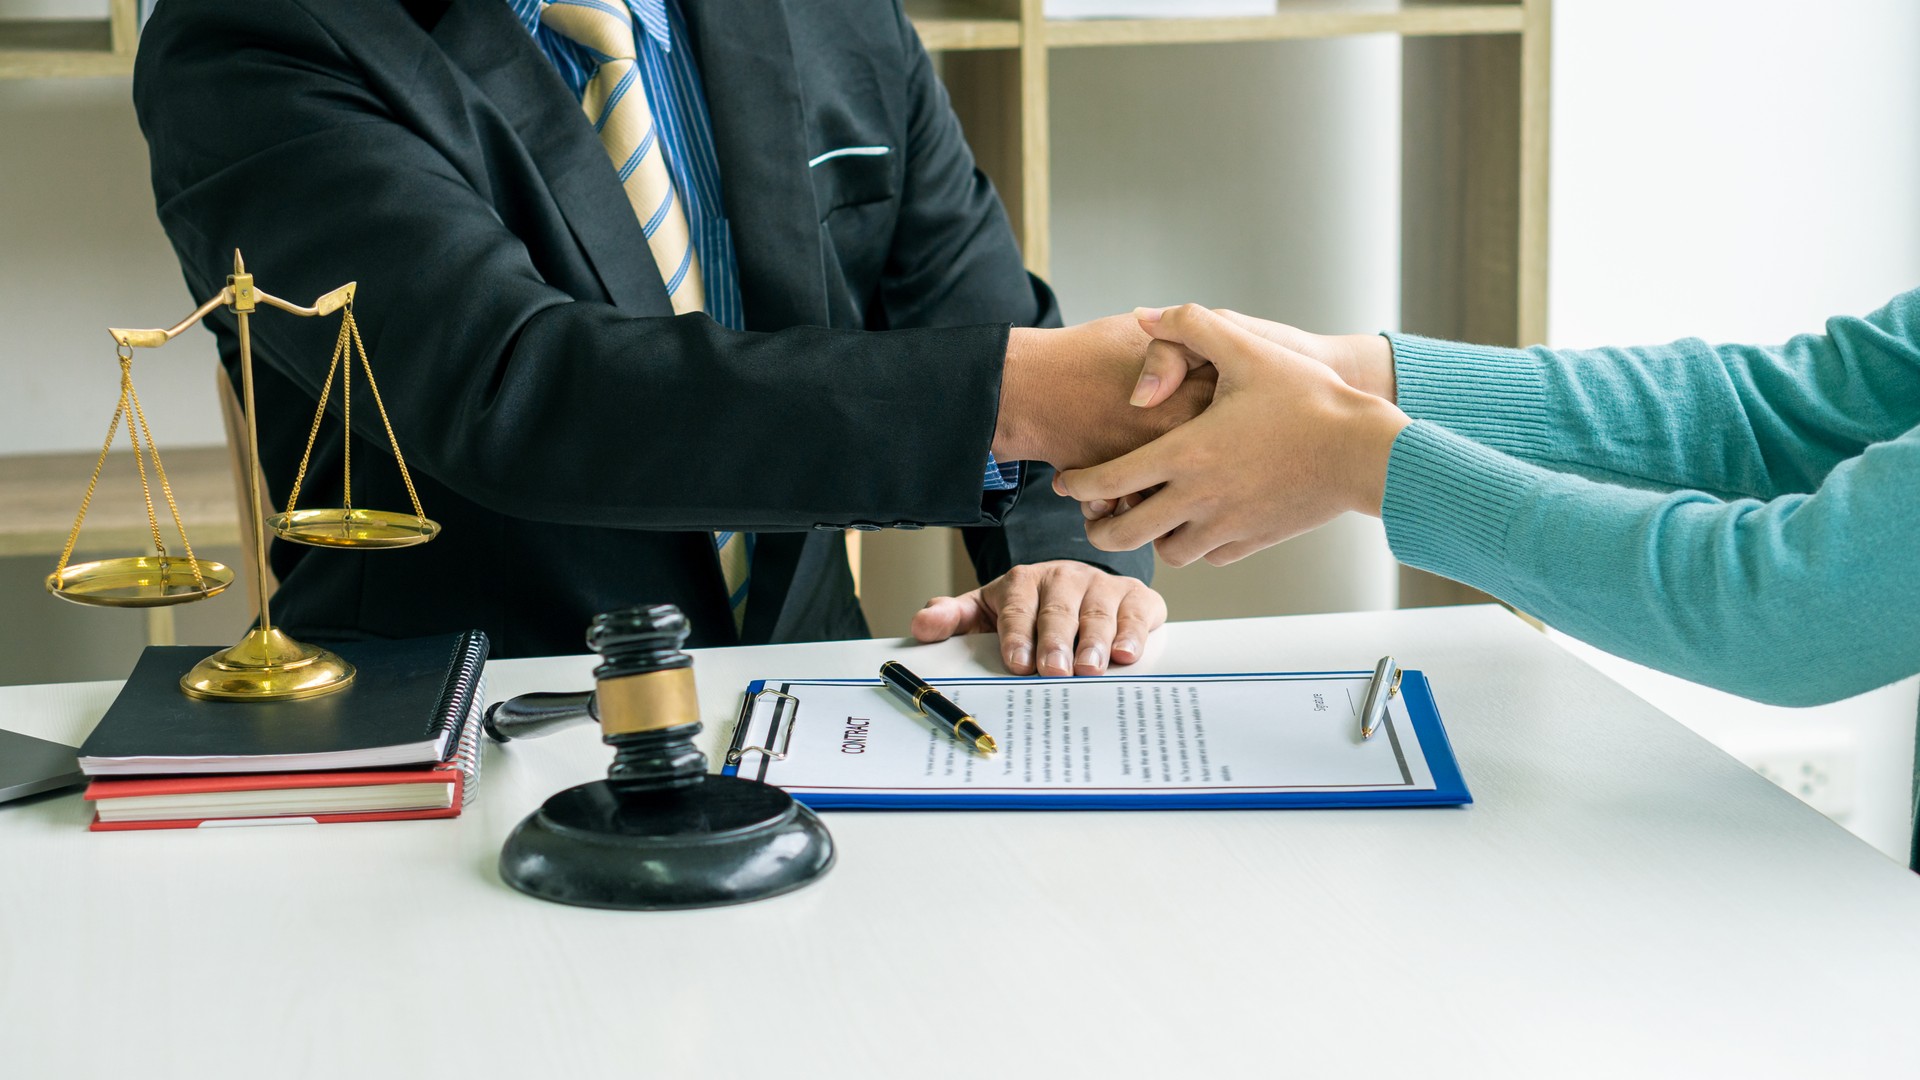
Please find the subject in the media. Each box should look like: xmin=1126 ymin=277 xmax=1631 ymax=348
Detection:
xmin=906 ymin=0 xmax=1551 ymax=605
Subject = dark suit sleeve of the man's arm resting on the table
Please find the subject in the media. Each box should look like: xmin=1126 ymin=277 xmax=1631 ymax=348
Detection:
xmin=881 ymin=6 xmax=1154 ymax=582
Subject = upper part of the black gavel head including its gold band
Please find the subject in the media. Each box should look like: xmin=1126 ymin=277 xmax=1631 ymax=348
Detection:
xmin=588 ymin=603 xmax=701 ymax=738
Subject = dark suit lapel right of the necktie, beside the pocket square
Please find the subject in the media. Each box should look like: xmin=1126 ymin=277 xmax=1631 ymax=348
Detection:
xmin=680 ymin=0 xmax=828 ymax=331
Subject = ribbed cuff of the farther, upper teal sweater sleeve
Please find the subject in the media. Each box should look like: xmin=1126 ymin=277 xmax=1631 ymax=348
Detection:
xmin=1386 ymin=334 xmax=1551 ymax=461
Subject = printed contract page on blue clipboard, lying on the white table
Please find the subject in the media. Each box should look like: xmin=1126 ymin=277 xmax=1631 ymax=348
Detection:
xmin=726 ymin=671 xmax=1471 ymax=809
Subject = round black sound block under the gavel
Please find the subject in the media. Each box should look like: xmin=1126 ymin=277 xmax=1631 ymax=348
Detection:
xmin=499 ymin=776 xmax=833 ymax=911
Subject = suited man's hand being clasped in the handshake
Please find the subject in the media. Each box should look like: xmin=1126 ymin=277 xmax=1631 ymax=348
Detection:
xmin=993 ymin=315 xmax=1213 ymax=469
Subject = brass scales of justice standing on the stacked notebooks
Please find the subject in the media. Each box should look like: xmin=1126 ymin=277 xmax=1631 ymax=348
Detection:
xmin=46 ymin=250 xmax=440 ymax=701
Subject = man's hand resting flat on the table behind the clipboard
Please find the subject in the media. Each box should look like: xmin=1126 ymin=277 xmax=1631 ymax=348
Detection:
xmin=914 ymin=559 xmax=1167 ymax=676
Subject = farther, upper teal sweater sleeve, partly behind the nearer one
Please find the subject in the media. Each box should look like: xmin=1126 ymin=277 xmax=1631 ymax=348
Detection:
xmin=1392 ymin=290 xmax=1920 ymax=498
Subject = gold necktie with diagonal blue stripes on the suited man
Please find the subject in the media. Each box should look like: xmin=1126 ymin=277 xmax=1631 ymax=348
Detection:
xmin=540 ymin=0 xmax=751 ymax=632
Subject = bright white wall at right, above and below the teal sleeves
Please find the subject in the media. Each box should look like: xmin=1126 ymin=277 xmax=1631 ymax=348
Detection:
xmin=1548 ymin=0 xmax=1920 ymax=859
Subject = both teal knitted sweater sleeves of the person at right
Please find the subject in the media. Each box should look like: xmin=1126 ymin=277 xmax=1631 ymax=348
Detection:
xmin=1382 ymin=294 xmax=1920 ymax=705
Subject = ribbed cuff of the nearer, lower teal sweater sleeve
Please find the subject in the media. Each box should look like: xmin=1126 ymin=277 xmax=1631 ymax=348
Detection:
xmin=1380 ymin=421 xmax=1536 ymax=596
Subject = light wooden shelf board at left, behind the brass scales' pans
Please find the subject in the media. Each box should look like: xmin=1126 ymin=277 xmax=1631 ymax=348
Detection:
xmin=0 ymin=446 xmax=240 ymax=557
